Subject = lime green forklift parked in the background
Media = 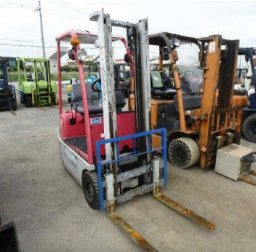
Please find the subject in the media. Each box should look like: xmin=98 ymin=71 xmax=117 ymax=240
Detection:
xmin=17 ymin=58 xmax=57 ymax=107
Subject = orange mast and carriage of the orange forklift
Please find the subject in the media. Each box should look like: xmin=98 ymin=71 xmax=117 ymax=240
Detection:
xmin=199 ymin=35 xmax=243 ymax=168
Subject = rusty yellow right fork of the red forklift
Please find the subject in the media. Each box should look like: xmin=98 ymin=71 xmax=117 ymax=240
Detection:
xmin=155 ymin=193 xmax=216 ymax=229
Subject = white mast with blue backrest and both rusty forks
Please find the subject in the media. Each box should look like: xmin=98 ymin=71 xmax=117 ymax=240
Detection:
xmin=87 ymin=10 xmax=215 ymax=251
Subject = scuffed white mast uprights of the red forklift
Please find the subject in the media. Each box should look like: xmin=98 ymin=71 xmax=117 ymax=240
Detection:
xmin=91 ymin=11 xmax=151 ymax=165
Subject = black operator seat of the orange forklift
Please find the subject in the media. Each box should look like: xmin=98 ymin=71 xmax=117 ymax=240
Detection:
xmin=150 ymin=71 xmax=176 ymax=99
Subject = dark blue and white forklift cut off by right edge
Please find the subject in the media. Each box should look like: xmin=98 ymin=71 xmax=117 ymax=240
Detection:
xmin=238 ymin=47 xmax=256 ymax=143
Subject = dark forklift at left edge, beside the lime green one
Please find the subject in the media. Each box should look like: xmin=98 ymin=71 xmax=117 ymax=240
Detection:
xmin=0 ymin=57 xmax=17 ymax=111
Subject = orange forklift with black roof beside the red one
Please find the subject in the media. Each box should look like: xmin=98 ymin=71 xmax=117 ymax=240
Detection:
xmin=146 ymin=32 xmax=247 ymax=169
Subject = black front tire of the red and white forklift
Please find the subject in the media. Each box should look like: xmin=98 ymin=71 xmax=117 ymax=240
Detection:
xmin=82 ymin=171 xmax=100 ymax=209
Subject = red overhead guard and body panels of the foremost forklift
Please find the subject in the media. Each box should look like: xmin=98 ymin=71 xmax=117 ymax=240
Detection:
xmin=56 ymin=30 xmax=132 ymax=164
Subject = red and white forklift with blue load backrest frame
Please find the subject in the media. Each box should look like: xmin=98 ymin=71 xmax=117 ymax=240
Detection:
xmin=56 ymin=10 xmax=215 ymax=251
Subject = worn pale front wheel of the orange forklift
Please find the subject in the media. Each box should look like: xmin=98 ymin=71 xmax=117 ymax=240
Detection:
xmin=168 ymin=137 xmax=200 ymax=169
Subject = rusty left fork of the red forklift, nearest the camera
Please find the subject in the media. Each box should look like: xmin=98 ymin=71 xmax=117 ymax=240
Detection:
xmin=108 ymin=211 xmax=157 ymax=252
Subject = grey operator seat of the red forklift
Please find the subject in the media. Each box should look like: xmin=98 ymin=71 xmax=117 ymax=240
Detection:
xmin=71 ymin=83 xmax=126 ymax=115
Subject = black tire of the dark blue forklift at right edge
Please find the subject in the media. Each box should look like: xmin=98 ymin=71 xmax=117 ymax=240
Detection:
xmin=242 ymin=114 xmax=256 ymax=143
